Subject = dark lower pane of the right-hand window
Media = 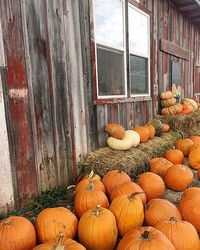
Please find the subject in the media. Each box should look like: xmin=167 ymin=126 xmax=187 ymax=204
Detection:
xmin=130 ymin=55 xmax=149 ymax=94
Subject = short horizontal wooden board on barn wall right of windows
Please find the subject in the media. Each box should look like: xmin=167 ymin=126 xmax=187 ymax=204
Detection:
xmin=160 ymin=39 xmax=190 ymax=61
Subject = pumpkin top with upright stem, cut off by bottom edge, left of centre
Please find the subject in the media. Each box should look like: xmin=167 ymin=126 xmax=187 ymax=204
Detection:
xmin=33 ymin=234 xmax=86 ymax=250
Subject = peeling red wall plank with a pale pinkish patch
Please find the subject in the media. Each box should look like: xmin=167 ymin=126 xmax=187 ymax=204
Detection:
xmin=0 ymin=0 xmax=37 ymax=206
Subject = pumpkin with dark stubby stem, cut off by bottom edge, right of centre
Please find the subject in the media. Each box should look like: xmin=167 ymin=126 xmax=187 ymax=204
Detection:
xmin=117 ymin=227 xmax=175 ymax=250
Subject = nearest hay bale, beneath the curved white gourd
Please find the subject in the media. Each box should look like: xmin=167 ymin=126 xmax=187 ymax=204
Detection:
xmin=81 ymin=133 xmax=177 ymax=180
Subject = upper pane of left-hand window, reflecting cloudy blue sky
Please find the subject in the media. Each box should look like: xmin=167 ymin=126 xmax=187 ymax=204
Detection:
xmin=94 ymin=0 xmax=124 ymax=47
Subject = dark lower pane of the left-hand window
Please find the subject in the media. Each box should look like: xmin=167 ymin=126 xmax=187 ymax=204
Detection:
xmin=97 ymin=47 xmax=125 ymax=96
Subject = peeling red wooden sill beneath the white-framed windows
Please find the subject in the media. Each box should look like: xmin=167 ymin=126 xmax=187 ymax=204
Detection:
xmin=94 ymin=96 xmax=152 ymax=105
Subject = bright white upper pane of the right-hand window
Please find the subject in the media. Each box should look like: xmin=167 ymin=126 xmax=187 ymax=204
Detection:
xmin=128 ymin=6 xmax=149 ymax=55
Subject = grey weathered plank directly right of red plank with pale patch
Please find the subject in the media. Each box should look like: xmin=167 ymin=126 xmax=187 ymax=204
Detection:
xmin=23 ymin=0 xmax=58 ymax=191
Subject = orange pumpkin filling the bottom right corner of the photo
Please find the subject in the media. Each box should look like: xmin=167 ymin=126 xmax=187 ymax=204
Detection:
xmin=155 ymin=217 xmax=200 ymax=250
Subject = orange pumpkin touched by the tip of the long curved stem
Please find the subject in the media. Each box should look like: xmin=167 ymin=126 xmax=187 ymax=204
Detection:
xmin=138 ymin=172 xmax=165 ymax=201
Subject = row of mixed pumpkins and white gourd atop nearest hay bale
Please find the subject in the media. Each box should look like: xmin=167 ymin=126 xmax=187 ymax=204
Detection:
xmin=105 ymin=119 xmax=169 ymax=150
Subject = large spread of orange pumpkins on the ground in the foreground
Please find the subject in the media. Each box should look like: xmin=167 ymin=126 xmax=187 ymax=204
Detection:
xmin=0 ymin=136 xmax=200 ymax=250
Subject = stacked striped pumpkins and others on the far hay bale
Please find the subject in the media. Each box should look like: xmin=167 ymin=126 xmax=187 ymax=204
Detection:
xmin=160 ymin=91 xmax=200 ymax=115
